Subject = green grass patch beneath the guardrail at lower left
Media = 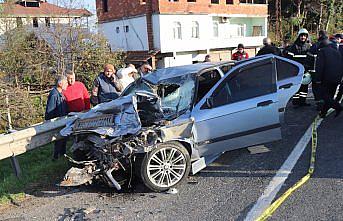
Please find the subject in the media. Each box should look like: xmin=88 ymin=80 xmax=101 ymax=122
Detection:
xmin=0 ymin=144 xmax=70 ymax=205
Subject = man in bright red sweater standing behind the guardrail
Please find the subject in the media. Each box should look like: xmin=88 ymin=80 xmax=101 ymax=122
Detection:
xmin=63 ymin=70 xmax=91 ymax=112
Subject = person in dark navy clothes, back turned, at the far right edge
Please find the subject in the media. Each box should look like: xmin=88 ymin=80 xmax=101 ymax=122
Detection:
xmin=313 ymin=40 xmax=343 ymax=117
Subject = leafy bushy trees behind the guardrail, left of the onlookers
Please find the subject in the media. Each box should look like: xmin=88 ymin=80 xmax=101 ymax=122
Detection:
xmin=0 ymin=0 xmax=124 ymax=131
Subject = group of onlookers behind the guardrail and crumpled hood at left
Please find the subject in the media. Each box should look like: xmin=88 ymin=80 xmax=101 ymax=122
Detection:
xmin=45 ymin=63 xmax=152 ymax=160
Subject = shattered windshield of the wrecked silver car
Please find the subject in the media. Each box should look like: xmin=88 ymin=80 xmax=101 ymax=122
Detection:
xmin=123 ymin=74 xmax=195 ymax=117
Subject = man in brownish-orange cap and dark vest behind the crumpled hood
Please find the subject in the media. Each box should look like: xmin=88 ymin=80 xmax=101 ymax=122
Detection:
xmin=91 ymin=64 xmax=123 ymax=105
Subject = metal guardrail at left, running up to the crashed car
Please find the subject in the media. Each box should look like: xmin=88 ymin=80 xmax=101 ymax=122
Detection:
xmin=0 ymin=116 xmax=76 ymax=160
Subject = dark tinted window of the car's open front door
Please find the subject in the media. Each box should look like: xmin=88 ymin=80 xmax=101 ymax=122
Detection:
xmin=212 ymin=62 xmax=276 ymax=107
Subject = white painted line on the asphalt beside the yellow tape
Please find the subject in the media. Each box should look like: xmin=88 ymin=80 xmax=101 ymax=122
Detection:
xmin=245 ymin=116 xmax=326 ymax=221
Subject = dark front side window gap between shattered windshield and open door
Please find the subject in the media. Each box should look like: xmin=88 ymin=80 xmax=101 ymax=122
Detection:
xmin=195 ymin=70 xmax=221 ymax=103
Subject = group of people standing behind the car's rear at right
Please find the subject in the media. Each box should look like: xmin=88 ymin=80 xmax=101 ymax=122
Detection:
xmin=232 ymin=29 xmax=343 ymax=117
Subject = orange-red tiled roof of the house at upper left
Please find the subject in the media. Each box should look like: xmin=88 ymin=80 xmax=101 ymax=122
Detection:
xmin=2 ymin=2 xmax=92 ymax=17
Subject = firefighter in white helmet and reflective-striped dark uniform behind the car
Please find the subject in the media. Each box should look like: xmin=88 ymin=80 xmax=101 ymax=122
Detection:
xmin=285 ymin=28 xmax=311 ymax=106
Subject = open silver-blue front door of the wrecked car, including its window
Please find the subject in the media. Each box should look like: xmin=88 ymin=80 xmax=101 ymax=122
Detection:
xmin=192 ymin=58 xmax=281 ymax=156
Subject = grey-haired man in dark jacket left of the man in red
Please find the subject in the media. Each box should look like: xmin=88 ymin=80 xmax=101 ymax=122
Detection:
xmin=45 ymin=76 xmax=68 ymax=160
